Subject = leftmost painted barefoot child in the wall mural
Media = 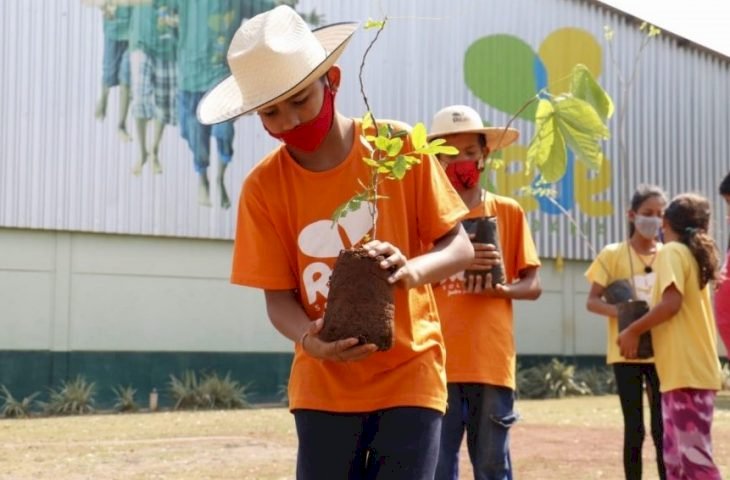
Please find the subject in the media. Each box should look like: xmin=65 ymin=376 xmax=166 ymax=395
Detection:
xmin=95 ymin=2 xmax=132 ymax=142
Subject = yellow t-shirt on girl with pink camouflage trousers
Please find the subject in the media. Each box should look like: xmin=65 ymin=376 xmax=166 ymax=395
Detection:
xmin=651 ymin=242 xmax=722 ymax=392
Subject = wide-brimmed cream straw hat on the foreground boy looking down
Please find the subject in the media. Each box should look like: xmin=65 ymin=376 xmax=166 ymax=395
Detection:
xmin=198 ymin=5 xmax=357 ymax=124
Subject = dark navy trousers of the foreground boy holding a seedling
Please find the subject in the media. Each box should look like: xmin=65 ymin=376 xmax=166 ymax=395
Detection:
xmin=293 ymin=407 xmax=442 ymax=480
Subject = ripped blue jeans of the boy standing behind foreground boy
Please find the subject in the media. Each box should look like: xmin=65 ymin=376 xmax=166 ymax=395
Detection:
xmin=436 ymin=383 xmax=518 ymax=480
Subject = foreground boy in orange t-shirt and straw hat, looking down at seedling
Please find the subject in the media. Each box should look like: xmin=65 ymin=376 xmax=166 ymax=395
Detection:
xmin=198 ymin=6 xmax=473 ymax=479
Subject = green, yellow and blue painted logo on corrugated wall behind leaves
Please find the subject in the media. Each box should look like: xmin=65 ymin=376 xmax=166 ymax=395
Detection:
xmin=464 ymin=28 xmax=614 ymax=244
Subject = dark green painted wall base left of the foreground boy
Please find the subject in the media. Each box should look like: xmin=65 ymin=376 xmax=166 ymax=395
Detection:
xmin=0 ymin=350 xmax=292 ymax=409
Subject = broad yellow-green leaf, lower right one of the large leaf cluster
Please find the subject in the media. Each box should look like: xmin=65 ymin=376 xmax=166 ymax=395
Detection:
xmin=553 ymin=96 xmax=609 ymax=169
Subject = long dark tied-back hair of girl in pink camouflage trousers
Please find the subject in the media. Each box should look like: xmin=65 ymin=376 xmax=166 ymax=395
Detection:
xmin=664 ymin=193 xmax=720 ymax=288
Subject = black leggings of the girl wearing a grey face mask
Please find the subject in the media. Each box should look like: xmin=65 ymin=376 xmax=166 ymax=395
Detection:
xmin=613 ymin=363 xmax=667 ymax=480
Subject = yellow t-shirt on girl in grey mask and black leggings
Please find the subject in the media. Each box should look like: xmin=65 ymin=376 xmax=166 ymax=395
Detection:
xmin=585 ymin=242 xmax=662 ymax=364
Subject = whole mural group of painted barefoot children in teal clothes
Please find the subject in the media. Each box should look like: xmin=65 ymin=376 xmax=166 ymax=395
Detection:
xmin=87 ymin=0 xmax=275 ymax=209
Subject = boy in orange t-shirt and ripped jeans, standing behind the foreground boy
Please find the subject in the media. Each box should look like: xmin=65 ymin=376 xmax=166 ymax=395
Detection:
xmin=429 ymin=105 xmax=542 ymax=480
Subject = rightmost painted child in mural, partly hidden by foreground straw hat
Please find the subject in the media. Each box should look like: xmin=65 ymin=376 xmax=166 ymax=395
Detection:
xmin=177 ymin=0 xmax=275 ymax=209
